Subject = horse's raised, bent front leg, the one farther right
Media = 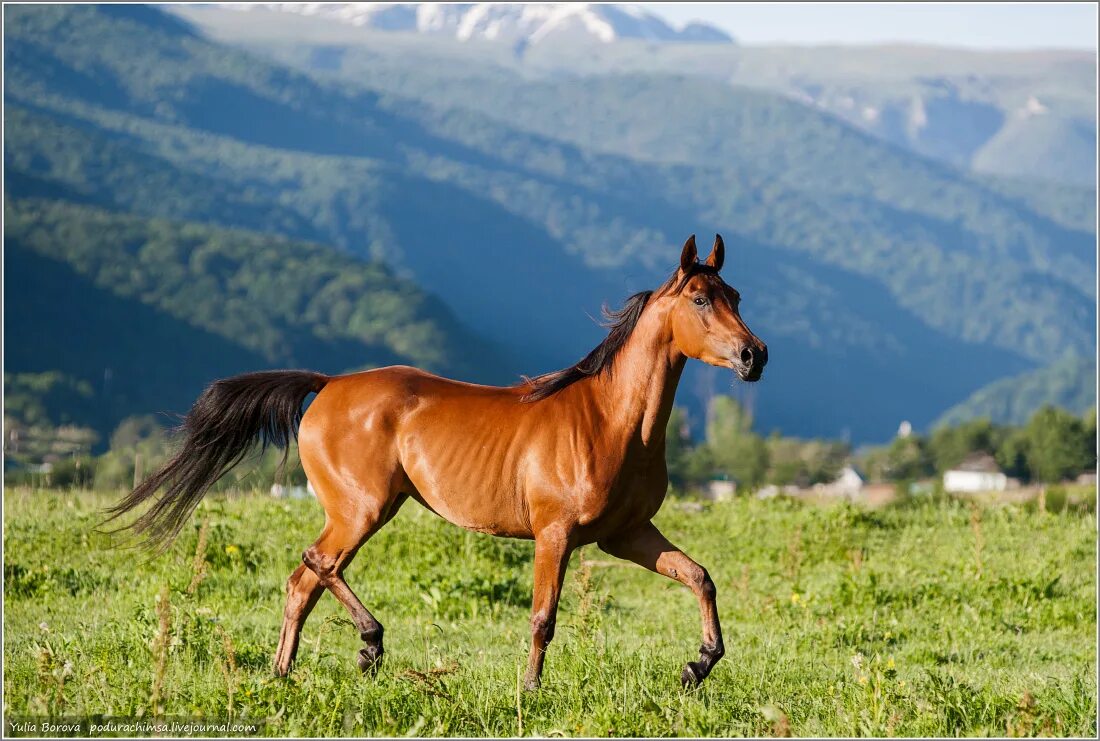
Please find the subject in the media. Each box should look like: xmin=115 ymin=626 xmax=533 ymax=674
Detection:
xmin=598 ymin=522 xmax=726 ymax=687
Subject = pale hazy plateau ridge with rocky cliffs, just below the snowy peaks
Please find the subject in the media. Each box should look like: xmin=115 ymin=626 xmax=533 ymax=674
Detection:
xmin=184 ymin=5 xmax=1097 ymax=188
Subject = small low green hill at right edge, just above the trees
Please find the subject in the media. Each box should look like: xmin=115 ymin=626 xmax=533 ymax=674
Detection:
xmin=936 ymin=355 xmax=1097 ymax=425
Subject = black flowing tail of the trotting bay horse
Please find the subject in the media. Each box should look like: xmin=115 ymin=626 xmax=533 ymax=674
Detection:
xmin=108 ymin=371 xmax=329 ymax=551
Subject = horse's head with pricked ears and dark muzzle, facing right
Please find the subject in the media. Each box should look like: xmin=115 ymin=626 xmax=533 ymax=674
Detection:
xmin=660 ymin=234 xmax=768 ymax=381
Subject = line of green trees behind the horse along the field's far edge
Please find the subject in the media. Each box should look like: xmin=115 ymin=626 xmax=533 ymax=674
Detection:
xmin=4 ymin=396 xmax=1097 ymax=494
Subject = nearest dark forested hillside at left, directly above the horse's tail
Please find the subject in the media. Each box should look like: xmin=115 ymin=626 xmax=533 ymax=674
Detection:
xmin=4 ymin=199 xmax=509 ymax=432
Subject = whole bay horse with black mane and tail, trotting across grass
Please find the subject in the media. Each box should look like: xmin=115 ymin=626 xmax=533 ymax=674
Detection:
xmin=109 ymin=235 xmax=768 ymax=689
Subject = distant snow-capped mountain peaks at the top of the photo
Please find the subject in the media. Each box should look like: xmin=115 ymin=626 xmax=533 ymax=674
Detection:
xmin=227 ymin=2 xmax=733 ymax=48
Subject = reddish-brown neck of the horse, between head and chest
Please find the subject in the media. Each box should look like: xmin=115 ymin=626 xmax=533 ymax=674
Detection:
xmin=597 ymin=301 xmax=686 ymax=449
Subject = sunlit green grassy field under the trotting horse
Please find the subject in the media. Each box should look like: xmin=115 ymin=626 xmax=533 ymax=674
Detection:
xmin=3 ymin=489 xmax=1097 ymax=737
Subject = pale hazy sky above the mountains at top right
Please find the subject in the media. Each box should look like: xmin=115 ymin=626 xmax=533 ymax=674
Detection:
xmin=649 ymin=2 xmax=1097 ymax=49
